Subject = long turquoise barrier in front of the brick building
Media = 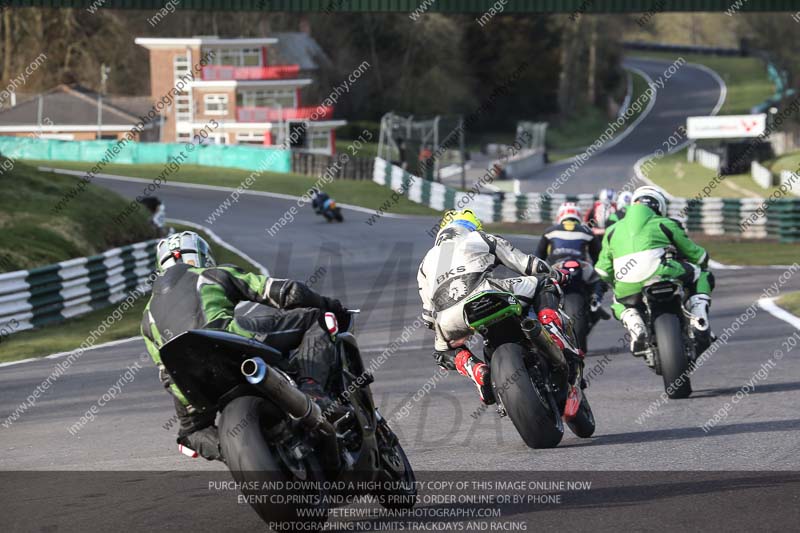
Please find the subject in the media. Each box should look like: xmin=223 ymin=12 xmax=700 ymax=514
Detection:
xmin=0 ymin=136 xmax=292 ymax=173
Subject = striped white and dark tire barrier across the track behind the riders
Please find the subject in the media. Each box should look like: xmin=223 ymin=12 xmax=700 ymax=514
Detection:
xmin=373 ymin=158 xmax=800 ymax=242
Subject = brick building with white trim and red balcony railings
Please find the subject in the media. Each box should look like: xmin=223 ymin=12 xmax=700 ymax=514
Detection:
xmin=136 ymin=33 xmax=346 ymax=154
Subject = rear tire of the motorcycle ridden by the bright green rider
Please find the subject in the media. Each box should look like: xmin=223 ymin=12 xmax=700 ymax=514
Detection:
xmin=653 ymin=313 xmax=692 ymax=400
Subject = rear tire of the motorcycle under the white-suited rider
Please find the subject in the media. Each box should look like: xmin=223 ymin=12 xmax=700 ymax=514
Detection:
xmin=492 ymin=343 xmax=564 ymax=449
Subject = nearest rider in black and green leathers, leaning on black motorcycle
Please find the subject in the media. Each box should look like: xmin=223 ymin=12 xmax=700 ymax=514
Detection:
xmin=141 ymin=231 xmax=348 ymax=460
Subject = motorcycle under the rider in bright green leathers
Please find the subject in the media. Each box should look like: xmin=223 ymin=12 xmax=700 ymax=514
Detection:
xmin=623 ymin=278 xmax=711 ymax=399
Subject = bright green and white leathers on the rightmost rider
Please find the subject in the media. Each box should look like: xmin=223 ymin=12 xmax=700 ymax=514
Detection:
xmin=595 ymin=203 xmax=711 ymax=318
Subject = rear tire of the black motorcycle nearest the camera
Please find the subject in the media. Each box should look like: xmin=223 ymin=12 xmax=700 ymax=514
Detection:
xmin=219 ymin=396 xmax=327 ymax=531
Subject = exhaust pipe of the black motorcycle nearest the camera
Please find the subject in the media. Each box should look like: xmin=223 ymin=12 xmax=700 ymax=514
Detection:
xmin=241 ymin=357 xmax=341 ymax=469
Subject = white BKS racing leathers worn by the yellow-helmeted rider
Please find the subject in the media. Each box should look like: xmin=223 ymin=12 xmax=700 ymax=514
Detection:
xmin=417 ymin=226 xmax=552 ymax=351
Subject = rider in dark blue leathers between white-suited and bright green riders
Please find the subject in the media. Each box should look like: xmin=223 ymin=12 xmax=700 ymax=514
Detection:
xmin=534 ymin=202 xmax=611 ymax=320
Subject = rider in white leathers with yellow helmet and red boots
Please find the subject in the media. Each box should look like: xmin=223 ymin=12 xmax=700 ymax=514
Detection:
xmin=417 ymin=209 xmax=579 ymax=405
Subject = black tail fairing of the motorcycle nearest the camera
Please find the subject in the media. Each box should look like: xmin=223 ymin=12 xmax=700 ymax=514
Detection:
xmin=159 ymin=330 xmax=285 ymax=412
